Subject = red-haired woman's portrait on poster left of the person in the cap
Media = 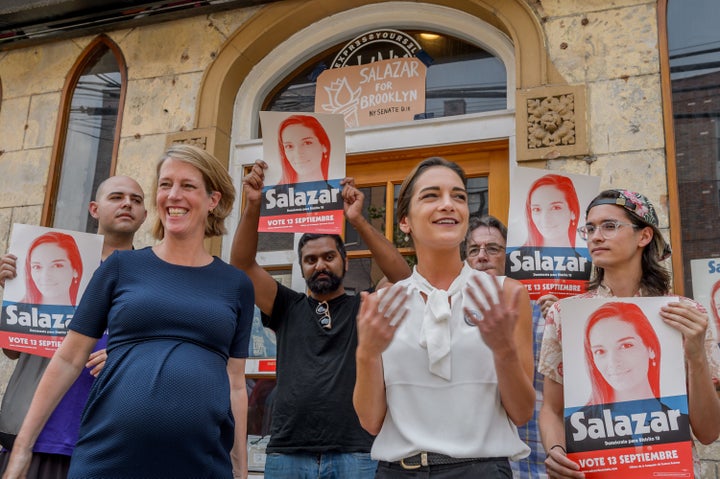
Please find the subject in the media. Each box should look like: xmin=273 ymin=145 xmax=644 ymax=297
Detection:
xmin=524 ymin=173 xmax=580 ymax=248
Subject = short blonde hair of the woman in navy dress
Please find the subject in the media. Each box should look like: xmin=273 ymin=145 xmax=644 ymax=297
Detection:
xmin=153 ymin=144 xmax=235 ymax=240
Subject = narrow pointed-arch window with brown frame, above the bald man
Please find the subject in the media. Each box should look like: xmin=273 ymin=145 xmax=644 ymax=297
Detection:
xmin=45 ymin=37 xmax=125 ymax=233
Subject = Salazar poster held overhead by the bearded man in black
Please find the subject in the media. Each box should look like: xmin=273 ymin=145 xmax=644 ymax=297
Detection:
xmin=258 ymin=111 xmax=345 ymax=234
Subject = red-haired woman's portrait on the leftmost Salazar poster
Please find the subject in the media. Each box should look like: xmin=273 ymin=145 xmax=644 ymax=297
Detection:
xmin=21 ymin=231 xmax=83 ymax=306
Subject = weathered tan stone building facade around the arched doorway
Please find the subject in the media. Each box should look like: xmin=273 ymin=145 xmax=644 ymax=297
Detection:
xmin=0 ymin=0 xmax=720 ymax=479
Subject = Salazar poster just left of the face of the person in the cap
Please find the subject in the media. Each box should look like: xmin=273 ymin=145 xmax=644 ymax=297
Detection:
xmin=505 ymin=167 xmax=600 ymax=300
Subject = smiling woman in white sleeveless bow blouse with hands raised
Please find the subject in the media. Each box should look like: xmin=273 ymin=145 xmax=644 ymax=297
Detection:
xmin=353 ymin=158 xmax=535 ymax=478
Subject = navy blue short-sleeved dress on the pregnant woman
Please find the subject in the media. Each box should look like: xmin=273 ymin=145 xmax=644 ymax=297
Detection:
xmin=68 ymin=248 xmax=254 ymax=479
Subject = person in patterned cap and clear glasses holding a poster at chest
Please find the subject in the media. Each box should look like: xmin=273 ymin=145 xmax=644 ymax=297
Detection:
xmin=538 ymin=190 xmax=720 ymax=478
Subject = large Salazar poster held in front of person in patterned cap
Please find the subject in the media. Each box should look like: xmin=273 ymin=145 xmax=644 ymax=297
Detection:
xmin=561 ymin=297 xmax=693 ymax=479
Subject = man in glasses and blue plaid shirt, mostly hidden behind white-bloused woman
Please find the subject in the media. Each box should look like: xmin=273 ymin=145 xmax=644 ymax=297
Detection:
xmin=462 ymin=215 xmax=557 ymax=479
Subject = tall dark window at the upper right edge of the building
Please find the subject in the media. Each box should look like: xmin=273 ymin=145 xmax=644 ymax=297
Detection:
xmin=667 ymin=0 xmax=720 ymax=296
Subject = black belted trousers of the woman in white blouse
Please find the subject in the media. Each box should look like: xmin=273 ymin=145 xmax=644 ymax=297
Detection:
xmin=375 ymin=458 xmax=512 ymax=479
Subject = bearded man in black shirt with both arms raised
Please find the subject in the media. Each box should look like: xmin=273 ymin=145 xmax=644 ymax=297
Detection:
xmin=230 ymin=160 xmax=411 ymax=479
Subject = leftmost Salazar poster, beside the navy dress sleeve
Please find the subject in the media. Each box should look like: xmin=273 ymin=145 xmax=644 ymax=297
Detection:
xmin=0 ymin=223 xmax=103 ymax=357
